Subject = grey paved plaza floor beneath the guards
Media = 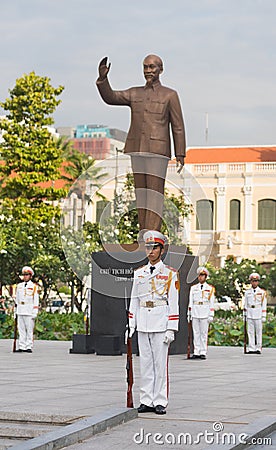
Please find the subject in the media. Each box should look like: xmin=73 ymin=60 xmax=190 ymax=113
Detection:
xmin=0 ymin=340 xmax=276 ymax=450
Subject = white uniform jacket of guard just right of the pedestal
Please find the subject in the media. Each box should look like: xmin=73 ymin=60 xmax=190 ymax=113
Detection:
xmin=189 ymin=282 xmax=215 ymax=319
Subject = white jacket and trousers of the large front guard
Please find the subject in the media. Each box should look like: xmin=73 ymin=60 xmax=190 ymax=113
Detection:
xmin=129 ymin=261 xmax=179 ymax=407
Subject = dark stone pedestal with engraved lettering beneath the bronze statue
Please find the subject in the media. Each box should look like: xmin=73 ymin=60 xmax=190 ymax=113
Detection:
xmin=71 ymin=244 xmax=198 ymax=355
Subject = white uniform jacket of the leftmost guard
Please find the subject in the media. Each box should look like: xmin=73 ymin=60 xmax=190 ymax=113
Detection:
xmin=16 ymin=280 xmax=39 ymax=317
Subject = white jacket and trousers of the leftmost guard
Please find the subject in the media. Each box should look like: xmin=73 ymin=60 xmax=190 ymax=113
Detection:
xmin=16 ymin=280 xmax=39 ymax=350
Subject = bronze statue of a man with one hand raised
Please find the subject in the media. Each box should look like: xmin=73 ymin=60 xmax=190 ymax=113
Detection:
xmin=97 ymin=55 xmax=186 ymax=232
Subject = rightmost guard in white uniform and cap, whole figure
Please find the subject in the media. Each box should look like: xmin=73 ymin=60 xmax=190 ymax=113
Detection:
xmin=244 ymin=272 xmax=267 ymax=355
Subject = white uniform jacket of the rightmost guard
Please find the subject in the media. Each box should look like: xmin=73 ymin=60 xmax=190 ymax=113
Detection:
xmin=244 ymin=286 xmax=267 ymax=319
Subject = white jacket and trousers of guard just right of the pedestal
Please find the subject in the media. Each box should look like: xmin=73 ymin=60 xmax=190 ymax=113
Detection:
xmin=188 ymin=282 xmax=215 ymax=356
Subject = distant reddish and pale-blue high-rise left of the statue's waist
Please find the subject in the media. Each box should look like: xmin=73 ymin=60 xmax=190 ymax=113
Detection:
xmin=72 ymin=124 xmax=127 ymax=160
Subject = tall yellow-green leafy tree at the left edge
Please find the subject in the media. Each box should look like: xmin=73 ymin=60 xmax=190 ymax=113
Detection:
xmin=0 ymin=72 xmax=66 ymax=297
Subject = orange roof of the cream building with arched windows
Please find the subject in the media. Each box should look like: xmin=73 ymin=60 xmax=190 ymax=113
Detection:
xmin=185 ymin=145 xmax=276 ymax=164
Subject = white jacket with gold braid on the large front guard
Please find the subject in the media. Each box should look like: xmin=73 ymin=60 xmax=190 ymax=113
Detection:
xmin=129 ymin=261 xmax=179 ymax=333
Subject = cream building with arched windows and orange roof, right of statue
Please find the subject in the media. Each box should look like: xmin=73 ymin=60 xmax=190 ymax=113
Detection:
xmin=168 ymin=145 xmax=276 ymax=267
